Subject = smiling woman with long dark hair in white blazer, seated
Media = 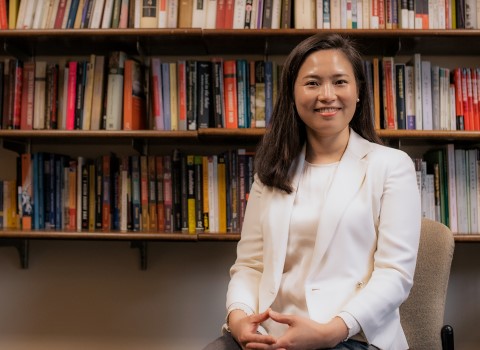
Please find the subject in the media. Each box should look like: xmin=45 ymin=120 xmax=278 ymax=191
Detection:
xmin=202 ymin=34 xmax=421 ymax=350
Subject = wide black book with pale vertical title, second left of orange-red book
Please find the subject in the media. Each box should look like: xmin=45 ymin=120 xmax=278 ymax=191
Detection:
xmin=197 ymin=61 xmax=213 ymax=128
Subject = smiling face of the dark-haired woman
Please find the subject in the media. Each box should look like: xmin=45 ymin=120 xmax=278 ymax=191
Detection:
xmin=294 ymin=49 xmax=358 ymax=136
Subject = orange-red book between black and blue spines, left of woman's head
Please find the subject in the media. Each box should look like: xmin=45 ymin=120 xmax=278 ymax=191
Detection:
xmin=223 ymin=60 xmax=238 ymax=128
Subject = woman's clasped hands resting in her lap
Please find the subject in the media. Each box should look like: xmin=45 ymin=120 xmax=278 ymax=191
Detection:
xmin=229 ymin=309 xmax=348 ymax=350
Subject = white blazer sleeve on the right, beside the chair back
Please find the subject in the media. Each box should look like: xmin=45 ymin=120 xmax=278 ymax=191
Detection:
xmin=343 ymin=150 xmax=421 ymax=340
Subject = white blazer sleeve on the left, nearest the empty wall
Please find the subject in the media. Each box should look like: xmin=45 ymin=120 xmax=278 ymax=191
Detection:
xmin=226 ymin=176 xmax=265 ymax=313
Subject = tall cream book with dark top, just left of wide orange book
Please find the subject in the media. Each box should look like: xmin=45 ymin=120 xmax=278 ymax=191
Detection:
xmin=106 ymin=51 xmax=126 ymax=130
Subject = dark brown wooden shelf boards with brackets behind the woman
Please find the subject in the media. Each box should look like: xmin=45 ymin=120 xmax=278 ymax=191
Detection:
xmin=0 ymin=29 xmax=480 ymax=267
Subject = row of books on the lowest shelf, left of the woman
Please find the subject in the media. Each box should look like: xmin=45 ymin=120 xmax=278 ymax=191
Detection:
xmin=0 ymin=149 xmax=253 ymax=234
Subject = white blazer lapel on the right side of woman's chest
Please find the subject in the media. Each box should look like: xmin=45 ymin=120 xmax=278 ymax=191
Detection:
xmin=310 ymin=130 xmax=370 ymax=272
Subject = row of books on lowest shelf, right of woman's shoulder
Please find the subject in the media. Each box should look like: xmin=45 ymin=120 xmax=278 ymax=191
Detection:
xmin=413 ymin=144 xmax=480 ymax=234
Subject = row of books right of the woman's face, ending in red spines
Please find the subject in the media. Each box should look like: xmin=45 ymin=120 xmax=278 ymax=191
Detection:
xmin=372 ymin=54 xmax=480 ymax=131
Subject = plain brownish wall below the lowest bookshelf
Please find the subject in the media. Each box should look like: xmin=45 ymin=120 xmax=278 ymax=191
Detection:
xmin=0 ymin=240 xmax=480 ymax=350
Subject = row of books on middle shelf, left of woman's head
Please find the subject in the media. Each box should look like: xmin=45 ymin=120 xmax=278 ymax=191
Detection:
xmin=0 ymin=51 xmax=279 ymax=130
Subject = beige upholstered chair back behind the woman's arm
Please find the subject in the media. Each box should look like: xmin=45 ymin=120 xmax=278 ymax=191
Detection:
xmin=400 ymin=218 xmax=455 ymax=350
